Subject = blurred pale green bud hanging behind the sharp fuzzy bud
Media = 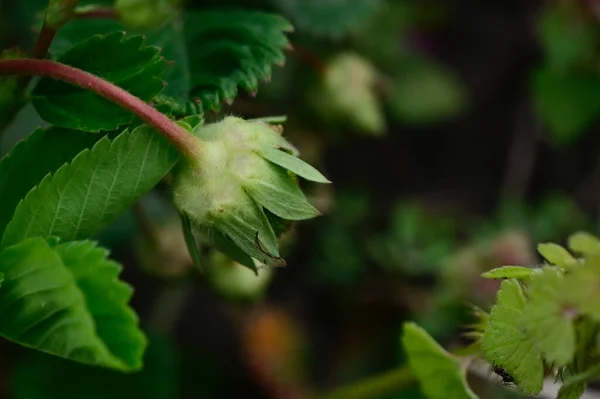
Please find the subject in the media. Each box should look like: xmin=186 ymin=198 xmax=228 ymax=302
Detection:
xmin=313 ymin=53 xmax=386 ymax=136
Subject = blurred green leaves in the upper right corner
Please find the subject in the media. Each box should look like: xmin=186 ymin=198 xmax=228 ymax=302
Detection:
xmin=531 ymin=1 xmax=600 ymax=144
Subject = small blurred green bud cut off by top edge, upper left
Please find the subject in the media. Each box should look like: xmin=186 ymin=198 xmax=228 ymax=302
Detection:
xmin=115 ymin=0 xmax=181 ymax=29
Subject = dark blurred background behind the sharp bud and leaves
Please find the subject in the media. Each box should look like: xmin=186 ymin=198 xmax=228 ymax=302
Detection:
xmin=0 ymin=0 xmax=600 ymax=399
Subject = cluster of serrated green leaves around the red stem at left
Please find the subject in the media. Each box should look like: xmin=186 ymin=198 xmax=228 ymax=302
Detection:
xmin=0 ymin=2 xmax=308 ymax=371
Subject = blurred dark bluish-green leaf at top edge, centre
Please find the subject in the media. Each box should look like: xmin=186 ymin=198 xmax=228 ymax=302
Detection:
xmin=271 ymin=0 xmax=381 ymax=37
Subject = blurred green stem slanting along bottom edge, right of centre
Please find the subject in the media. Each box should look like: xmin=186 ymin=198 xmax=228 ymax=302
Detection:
xmin=315 ymin=366 xmax=416 ymax=399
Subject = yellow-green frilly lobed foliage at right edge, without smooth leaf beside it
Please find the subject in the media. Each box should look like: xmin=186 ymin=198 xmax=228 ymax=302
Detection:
xmin=474 ymin=232 xmax=600 ymax=398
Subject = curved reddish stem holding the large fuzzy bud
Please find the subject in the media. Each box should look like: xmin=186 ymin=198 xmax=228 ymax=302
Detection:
xmin=0 ymin=59 xmax=197 ymax=157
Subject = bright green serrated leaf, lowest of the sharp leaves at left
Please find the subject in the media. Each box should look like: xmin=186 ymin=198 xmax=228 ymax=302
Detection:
xmin=0 ymin=238 xmax=146 ymax=371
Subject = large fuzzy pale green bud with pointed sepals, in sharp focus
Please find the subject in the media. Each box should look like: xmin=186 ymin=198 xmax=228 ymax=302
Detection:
xmin=174 ymin=117 xmax=329 ymax=266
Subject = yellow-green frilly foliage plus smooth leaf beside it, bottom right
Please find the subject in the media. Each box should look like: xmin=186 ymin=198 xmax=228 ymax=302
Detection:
xmin=403 ymin=232 xmax=600 ymax=399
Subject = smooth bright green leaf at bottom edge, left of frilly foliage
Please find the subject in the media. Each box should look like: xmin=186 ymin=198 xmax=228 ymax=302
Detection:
xmin=402 ymin=322 xmax=477 ymax=399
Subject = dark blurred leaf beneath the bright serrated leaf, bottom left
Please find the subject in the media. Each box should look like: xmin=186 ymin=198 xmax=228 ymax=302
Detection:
xmin=10 ymin=335 xmax=180 ymax=399
